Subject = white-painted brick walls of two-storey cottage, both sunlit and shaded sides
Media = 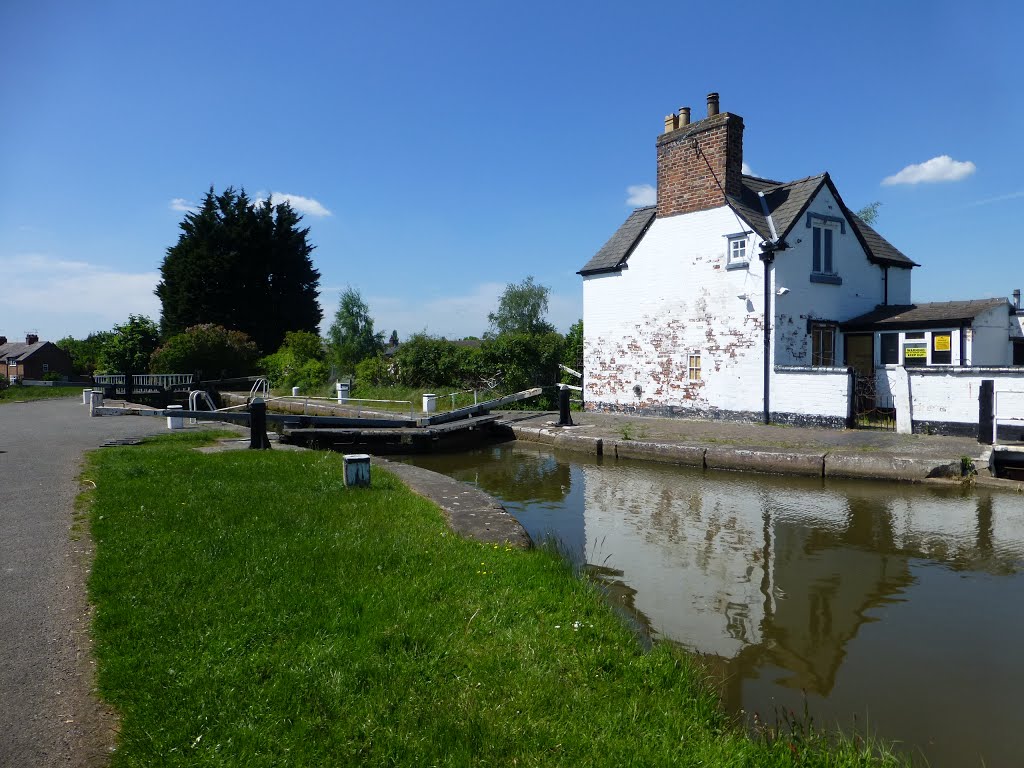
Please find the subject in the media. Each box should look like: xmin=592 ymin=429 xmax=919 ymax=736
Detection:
xmin=584 ymin=188 xmax=910 ymax=416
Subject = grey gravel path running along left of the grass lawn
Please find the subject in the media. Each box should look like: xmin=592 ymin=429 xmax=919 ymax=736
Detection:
xmin=0 ymin=399 xmax=167 ymax=768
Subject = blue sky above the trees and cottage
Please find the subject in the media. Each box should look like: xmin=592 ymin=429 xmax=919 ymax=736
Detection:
xmin=0 ymin=0 xmax=1024 ymax=339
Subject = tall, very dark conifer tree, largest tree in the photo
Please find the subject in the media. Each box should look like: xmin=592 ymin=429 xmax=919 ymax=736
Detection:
xmin=156 ymin=187 xmax=323 ymax=351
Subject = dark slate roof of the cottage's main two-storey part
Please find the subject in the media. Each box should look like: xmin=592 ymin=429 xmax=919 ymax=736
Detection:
xmin=579 ymin=173 xmax=919 ymax=274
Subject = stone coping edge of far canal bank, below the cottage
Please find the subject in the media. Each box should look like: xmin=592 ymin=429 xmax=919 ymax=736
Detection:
xmin=509 ymin=424 xmax=961 ymax=482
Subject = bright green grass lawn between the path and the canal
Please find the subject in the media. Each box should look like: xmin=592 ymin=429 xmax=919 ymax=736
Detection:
xmin=85 ymin=434 xmax=891 ymax=767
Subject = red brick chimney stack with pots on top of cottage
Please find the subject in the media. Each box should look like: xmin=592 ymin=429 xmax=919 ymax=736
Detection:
xmin=657 ymin=93 xmax=743 ymax=218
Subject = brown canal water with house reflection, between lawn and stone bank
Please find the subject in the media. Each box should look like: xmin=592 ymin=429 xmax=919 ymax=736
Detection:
xmin=411 ymin=443 xmax=1024 ymax=768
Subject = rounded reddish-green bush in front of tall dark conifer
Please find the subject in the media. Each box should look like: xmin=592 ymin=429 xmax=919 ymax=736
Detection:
xmin=150 ymin=323 xmax=259 ymax=379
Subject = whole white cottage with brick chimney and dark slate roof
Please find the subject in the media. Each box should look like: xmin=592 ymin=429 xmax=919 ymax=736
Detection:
xmin=580 ymin=93 xmax=1019 ymax=434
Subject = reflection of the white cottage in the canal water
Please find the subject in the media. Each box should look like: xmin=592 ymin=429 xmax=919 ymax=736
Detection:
xmin=582 ymin=466 xmax=1024 ymax=695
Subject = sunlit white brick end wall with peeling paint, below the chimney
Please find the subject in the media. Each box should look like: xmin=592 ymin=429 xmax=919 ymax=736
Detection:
xmin=584 ymin=208 xmax=763 ymax=411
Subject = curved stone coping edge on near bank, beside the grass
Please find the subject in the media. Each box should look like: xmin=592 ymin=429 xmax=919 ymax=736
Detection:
xmin=370 ymin=456 xmax=534 ymax=549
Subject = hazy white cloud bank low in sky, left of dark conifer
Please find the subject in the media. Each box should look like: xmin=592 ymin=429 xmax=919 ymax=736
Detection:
xmin=0 ymin=254 xmax=160 ymax=341
